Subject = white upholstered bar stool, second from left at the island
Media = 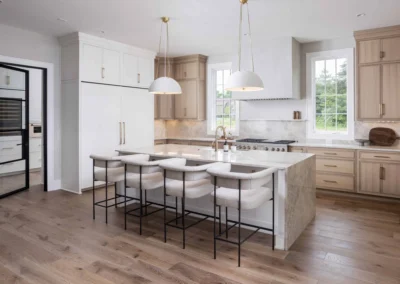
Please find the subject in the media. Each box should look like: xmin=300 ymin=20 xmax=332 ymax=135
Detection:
xmin=121 ymin=154 xmax=178 ymax=235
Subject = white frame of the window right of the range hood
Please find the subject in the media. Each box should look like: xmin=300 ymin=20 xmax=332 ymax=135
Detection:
xmin=306 ymin=48 xmax=355 ymax=140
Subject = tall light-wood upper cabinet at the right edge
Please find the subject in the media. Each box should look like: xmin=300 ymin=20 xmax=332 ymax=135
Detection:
xmin=354 ymin=26 xmax=400 ymax=120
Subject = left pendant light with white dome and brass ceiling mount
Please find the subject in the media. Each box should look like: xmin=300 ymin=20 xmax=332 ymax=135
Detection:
xmin=149 ymin=17 xmax=182 ymax=95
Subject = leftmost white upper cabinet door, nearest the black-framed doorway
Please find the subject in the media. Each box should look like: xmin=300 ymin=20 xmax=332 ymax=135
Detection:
xmin=81 ymin=44 xmax=103 ymax=83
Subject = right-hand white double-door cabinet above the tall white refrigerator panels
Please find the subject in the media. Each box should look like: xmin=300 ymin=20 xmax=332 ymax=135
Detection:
xmin=122 ymin=53 xmax=154 ymax=88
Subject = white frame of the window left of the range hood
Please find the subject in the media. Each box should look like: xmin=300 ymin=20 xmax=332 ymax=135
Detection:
xmin=207 ymin=62 xmax=240 ymax=136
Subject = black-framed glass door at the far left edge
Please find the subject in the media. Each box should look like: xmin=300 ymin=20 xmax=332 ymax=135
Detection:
xmin=0 ymin=64 xmax=29 ymax=198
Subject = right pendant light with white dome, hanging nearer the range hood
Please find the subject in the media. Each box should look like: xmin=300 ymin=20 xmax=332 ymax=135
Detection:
xmin=225 ymin=0 xmax=264 ymax=92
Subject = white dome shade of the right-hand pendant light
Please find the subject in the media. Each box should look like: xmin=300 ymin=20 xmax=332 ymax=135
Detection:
xmin=225 ymin=71 xmax=264 ymax=92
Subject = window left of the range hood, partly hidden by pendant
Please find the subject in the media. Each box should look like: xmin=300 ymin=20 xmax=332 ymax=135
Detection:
xmin=207 ymin=63 xmax=239 ymax=135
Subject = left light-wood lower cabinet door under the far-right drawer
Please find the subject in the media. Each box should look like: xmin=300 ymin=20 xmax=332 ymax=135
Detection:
xmin=359 ymin=162 xmax=381 ymax=193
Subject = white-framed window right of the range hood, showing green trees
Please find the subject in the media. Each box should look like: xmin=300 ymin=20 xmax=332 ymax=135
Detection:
xmin=307 ymin=49 xmax=354 ymax=139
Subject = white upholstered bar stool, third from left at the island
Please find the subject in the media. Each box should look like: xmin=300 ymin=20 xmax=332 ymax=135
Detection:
xmin=160 ymin=158 xmax=222 ymax=249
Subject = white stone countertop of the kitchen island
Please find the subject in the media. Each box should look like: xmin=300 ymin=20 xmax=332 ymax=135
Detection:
xmin=116 ymin=144 xmax=314 ymax=169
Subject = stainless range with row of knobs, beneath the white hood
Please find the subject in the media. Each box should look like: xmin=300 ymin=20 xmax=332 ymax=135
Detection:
xmin=235 ymin=138 xmax=296 ymax=152
